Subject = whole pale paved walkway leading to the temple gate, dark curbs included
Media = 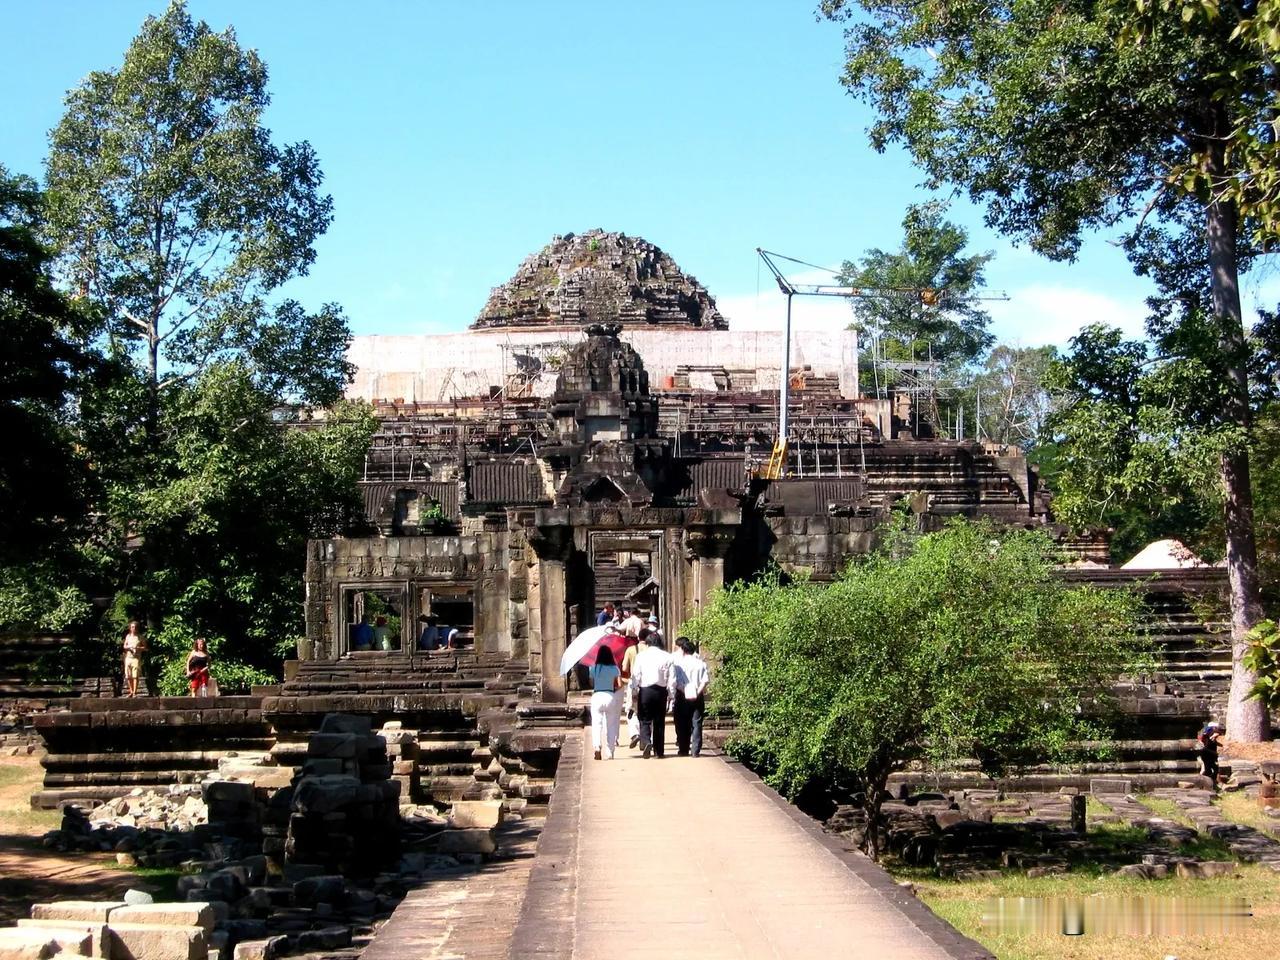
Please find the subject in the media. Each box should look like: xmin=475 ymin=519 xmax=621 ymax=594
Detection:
xmin=511 ymin=730 xmax=989 ymax=960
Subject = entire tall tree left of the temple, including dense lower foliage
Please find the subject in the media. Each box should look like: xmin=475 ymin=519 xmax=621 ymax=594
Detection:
xmin=36 ymin=3 xmax=372 ymax=692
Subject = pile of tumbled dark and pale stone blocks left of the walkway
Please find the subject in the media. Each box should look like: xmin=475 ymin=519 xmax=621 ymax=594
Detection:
xmin=28 ymin=714 xmax=511 ymax=960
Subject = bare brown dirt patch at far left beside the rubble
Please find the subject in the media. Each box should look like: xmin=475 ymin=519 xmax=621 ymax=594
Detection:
xmin=0 ymin=756 xmax=155 ymax=924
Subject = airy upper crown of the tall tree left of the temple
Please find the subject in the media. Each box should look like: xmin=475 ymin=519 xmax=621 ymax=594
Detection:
xmin=46 ymin=0 xmax=333 ymax=420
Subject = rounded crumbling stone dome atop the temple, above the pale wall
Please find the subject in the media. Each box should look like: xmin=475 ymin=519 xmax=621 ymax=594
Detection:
xmin=471 ymin=230 xmax=728 ymax=330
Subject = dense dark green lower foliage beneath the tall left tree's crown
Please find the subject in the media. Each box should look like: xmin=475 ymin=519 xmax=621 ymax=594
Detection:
xmin=96 ymin=361 xmax=375 ymax=669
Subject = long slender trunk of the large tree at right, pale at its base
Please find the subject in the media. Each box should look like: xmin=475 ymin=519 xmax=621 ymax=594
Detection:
xmin=1207 ymin=154 xmax=1271 ymax=744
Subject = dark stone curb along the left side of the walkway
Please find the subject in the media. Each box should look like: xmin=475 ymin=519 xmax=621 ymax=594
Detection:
xmin=507 ymin=727 xmax=582 ymax=960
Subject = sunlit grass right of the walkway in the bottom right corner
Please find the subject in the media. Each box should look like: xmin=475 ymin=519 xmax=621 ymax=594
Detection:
xmin=884 ymin=824 xmax=1280 ymax=960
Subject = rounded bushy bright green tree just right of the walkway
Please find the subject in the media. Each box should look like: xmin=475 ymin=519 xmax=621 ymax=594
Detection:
xmin=686 ymin=520 xmax=1148 ymax=856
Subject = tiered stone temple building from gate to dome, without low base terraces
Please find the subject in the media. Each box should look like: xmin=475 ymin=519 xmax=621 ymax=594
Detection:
xmin=317 ymin=230 xmax=1050 ymax=700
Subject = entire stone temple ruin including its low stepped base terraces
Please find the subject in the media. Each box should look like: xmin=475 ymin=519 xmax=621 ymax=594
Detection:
xmin=24 ymin=232 xmax=1254 ymax=810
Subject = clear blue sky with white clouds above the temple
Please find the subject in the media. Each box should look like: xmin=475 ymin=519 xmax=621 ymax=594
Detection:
xmin=0 ymin=0 xmax=1269 ymax=344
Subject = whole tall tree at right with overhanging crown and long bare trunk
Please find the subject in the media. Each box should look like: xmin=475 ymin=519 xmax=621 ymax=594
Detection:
xmin=820 ymin=0 xmax=1274 ymax=741
